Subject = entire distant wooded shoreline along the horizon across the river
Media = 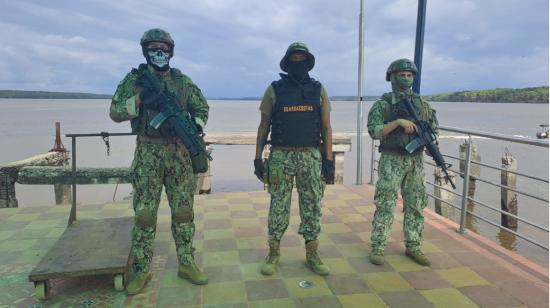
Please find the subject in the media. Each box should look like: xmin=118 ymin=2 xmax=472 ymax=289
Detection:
xmin=0 ymin=86 xmax=549 ymax=104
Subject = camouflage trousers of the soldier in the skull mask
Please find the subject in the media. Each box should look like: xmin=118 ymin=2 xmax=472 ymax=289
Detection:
xmin=131 ymin=142 xmax=196 ymax=272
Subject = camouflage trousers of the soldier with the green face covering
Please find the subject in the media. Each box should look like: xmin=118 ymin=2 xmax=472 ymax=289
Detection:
xmin=371 ymin=153 xmax=428 ymax=249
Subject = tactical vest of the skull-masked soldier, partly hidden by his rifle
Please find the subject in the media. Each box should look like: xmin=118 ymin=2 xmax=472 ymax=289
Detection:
xmin=130 ymin=68 xmax=188 ymax=138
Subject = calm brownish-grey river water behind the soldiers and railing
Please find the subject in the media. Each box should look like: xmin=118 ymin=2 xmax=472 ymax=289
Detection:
xmin=0 ymin=99 xmax=549 ymax=266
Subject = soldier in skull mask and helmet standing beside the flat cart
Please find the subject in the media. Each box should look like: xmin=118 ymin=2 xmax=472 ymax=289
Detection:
xmin=110 ymin=29 xmax=208 ymax=294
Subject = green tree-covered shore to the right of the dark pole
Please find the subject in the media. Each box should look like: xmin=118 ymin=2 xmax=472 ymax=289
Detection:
xmin=424 ymin=87 xmax=548 ymax=104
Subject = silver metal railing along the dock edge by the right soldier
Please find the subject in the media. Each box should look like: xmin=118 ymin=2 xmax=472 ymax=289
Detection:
xmin=369 ymin=126 xmax=549 ymax=250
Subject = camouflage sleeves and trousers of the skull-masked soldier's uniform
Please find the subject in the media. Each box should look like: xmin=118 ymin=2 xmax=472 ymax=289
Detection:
xmin=110 ymin=66 xmax=209 ymax=272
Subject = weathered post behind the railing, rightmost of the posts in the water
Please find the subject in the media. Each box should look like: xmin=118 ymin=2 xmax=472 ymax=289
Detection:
xmin=500 ymin=149 xmax=518 ymax=230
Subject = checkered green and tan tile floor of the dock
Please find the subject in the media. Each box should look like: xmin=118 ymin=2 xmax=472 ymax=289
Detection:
xmin=0 ymin=186 xmax=548 ymax=308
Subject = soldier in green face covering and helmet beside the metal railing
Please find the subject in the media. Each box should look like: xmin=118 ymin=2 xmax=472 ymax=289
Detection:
xmin=367 ymin=59 xmax=438 ymax=265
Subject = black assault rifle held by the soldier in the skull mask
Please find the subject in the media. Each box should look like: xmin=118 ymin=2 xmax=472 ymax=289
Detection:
xmin=136 ymin=64 xmax=212 ymax=160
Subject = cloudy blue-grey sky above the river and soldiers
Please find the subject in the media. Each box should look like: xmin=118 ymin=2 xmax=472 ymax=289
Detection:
xmin=0 ymin=0 xmax=549 ymax=98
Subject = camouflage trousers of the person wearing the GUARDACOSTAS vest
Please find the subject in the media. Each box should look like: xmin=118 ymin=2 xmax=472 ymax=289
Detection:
xmin=268 ymin=147 xmax=325 ymax=241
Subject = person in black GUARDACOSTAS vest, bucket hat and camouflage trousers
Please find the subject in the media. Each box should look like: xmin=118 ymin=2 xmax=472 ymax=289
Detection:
xmin=254 ymin=42 xmax=334 ymax=275
